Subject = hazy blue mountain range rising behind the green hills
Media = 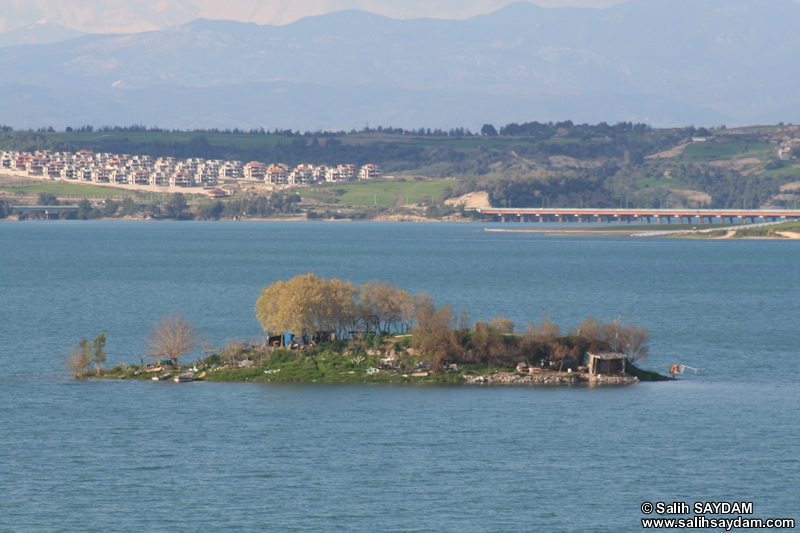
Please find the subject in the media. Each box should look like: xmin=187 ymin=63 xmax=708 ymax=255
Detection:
xmin=0 ymin=0 xmax=800 ymax=131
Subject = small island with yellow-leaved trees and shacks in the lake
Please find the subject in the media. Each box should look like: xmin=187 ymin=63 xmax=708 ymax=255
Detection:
xmin=67 ymin=274 xmax=670 ymax=385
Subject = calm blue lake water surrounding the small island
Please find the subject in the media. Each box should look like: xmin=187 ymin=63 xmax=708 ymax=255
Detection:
xmin=0 ymin=221 xmax=800 ymax=532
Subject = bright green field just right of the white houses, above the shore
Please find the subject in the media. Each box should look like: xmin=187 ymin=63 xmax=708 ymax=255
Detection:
xmin=302 ymin=179 xmax=454 ymax=207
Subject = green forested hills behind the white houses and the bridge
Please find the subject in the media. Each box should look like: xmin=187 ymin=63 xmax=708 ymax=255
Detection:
xmin=0 ymin=121 xmax=800 ymax=208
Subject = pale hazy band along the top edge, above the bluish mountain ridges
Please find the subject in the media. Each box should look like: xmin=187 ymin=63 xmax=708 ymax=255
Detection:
xmin=0 ymin=0 xmax=632 ymax=33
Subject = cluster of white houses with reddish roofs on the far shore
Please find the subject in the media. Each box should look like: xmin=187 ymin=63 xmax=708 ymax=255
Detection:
xmin=0 ymin=150 xmax=383 ymax=187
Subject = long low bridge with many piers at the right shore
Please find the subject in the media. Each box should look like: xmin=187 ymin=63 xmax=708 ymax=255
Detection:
xmin=476 ymin=207 xmax=800 ymax=224
